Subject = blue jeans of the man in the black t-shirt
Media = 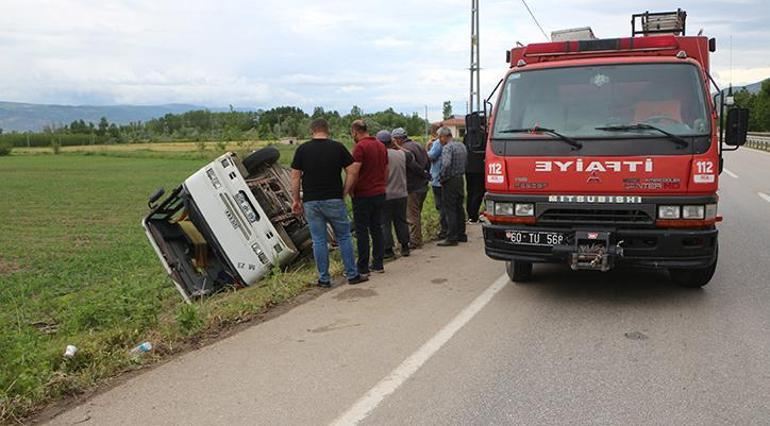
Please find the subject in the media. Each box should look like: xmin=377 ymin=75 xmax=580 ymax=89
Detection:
xmin=303 ymin=199 xmax=358 ymax=282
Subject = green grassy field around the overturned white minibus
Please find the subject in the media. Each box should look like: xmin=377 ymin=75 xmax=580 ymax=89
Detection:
xmin=0 ymin=144 xmax=436 ymax=423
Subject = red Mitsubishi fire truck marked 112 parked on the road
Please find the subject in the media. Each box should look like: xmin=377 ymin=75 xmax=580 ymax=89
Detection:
xmin=476 ymin=10 xmax=748 ymax=287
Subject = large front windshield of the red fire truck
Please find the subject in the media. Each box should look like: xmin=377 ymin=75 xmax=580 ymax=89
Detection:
xmin=493 ymin=63 xmax=710 ymax=140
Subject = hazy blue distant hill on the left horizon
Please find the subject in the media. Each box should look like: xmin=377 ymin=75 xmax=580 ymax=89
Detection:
xmin=0 ymin=102 xmax=204 ymax=132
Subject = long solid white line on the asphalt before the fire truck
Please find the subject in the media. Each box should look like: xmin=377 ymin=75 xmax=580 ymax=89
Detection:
xmin=332 ymin=275 xmax=509 ymax=426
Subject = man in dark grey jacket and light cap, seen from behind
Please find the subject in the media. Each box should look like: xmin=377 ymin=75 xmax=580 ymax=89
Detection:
xmin=391 ymin=127 xmax=430 ymax=249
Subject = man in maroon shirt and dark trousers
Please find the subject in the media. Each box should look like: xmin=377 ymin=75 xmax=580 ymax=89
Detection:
xmin=350 ymin=120 xmax=388 ymax=274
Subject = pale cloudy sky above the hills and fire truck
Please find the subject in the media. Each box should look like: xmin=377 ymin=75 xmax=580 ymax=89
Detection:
xmin=0 ymin=0 xmax=770 ymax=118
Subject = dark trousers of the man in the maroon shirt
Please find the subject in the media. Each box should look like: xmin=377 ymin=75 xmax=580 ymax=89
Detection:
xmin=353 ymin=194 xmax=385 ymax=274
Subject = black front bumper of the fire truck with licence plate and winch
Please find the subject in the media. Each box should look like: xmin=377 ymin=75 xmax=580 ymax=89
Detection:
xmin=483 ymin=224 xmax=718 ymax=271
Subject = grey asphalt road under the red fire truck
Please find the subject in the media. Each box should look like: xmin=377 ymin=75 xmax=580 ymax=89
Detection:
xmin=51 ymin=149 xmax=770 ymax=425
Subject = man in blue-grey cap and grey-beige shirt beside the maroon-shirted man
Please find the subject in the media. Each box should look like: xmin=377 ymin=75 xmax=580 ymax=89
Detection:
xmin=377 ymin=130 xmax=414 ymax=259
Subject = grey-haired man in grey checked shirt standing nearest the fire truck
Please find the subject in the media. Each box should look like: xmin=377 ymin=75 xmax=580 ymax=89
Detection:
xmin=438 ymin=127 xmax=468 ymax=247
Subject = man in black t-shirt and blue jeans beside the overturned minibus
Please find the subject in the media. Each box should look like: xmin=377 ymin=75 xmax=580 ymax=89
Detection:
xmin=291 ymin=119 xmax=368 ymax=287
